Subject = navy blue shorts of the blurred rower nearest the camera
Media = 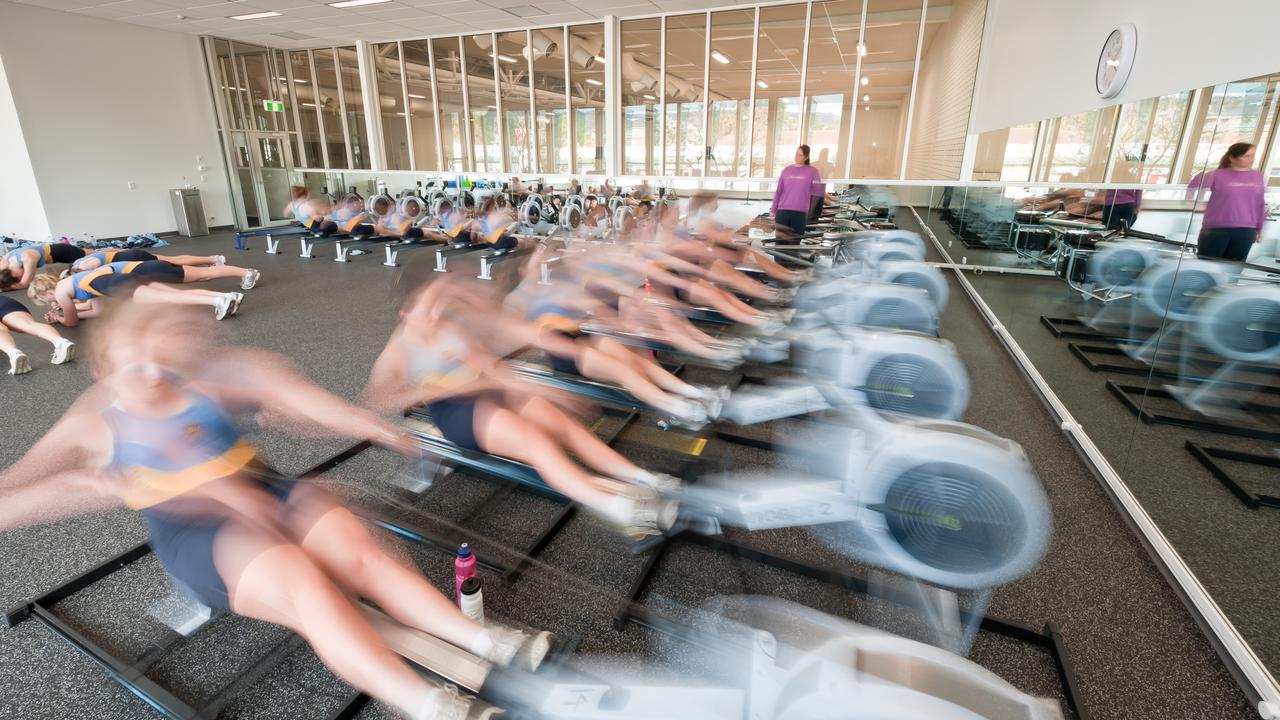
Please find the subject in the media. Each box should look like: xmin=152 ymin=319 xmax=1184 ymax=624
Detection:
xmin=142 ymin=466 xmax=297 ymax=611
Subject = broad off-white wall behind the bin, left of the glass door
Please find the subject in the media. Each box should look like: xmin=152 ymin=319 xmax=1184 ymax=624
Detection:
xmin=0 ymin=1 xmax=234 ymax=237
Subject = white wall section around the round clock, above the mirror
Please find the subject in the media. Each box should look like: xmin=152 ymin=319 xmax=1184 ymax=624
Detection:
xmin=970 ymin=0 xmax=1280 ymax=132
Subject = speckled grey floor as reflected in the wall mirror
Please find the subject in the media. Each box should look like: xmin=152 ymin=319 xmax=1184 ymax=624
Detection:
xmin=911 ymin=203 xmax=1280 ymax=681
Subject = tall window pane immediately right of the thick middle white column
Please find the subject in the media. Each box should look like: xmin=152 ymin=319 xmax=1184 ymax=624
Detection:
xmin=621 ymin=18 xmax=662 ymax=176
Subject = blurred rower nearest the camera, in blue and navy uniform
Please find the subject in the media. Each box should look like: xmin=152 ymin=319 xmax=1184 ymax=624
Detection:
xmin=0 ymin=304 xmax=548 ymax=720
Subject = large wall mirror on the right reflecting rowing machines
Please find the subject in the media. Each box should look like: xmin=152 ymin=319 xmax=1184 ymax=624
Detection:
xmin=920 ymin=76 xmax=1280 ymax=674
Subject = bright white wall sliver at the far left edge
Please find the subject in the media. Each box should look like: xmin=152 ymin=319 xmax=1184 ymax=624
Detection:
xmin=0 ymin=58 xmax=49 ymax=240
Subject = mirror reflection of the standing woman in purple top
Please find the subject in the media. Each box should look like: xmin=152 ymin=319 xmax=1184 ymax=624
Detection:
xmin=1187 ymin=142 xmax=1267 ymax=263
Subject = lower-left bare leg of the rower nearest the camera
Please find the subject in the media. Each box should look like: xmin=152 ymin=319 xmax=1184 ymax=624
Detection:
xmin=214 ymin=521 xmax=436 ymax=717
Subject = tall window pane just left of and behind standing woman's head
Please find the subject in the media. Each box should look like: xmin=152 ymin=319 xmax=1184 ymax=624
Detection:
xmin=751 ymin=5 xmax=805 ymax=177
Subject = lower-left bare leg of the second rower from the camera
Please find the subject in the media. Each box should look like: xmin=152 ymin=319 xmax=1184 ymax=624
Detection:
xmin=475 ymin=401 xmax=613 ymax=510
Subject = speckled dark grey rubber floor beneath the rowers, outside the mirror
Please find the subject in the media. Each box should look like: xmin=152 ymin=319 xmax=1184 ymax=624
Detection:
xmin=0 ymin=226 xmax=1253 ymax=720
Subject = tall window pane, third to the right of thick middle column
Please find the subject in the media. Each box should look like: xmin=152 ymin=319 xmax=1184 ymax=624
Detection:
xmin=707 ymin=10 xmax=755 ymax=177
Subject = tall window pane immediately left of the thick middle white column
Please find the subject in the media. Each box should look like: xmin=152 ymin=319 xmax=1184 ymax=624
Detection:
xmin=568 ymin=24 xmax=605 ymax=174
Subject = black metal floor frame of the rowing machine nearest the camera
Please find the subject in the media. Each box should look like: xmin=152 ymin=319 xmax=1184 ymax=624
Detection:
xmin=4 ymin=441 xmax=370 ymax=720
